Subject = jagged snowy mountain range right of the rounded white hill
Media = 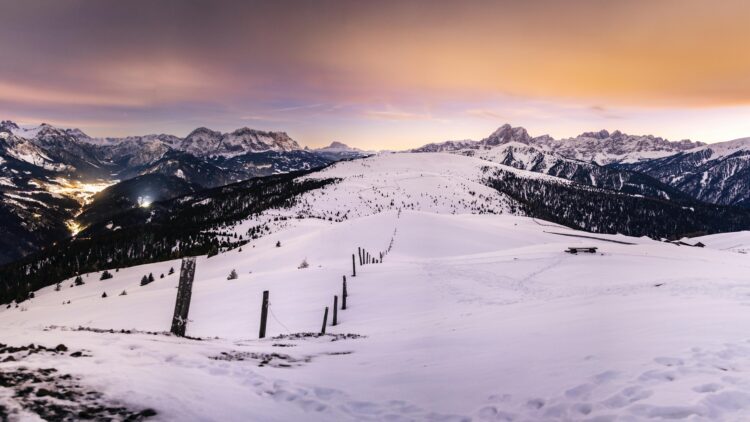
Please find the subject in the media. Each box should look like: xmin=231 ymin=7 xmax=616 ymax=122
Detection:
xmin=412 ymin=124 xmax=750 ymax=206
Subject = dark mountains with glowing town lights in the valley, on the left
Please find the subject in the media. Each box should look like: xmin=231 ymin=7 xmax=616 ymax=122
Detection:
xmin=0 ymin=120 xmax=356 ymax=263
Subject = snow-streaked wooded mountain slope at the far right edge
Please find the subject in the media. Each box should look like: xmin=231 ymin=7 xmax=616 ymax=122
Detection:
xmin=620 ymin=138 xmax=750 ymax=206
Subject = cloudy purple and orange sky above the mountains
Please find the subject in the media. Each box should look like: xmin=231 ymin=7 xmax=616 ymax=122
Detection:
xmin=0 ymin=0 xmax=750 ymax=149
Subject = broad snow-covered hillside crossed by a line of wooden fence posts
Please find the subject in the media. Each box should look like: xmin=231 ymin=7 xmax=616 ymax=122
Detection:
xmin=0 ymin=154 xmax=750 ymax=421
